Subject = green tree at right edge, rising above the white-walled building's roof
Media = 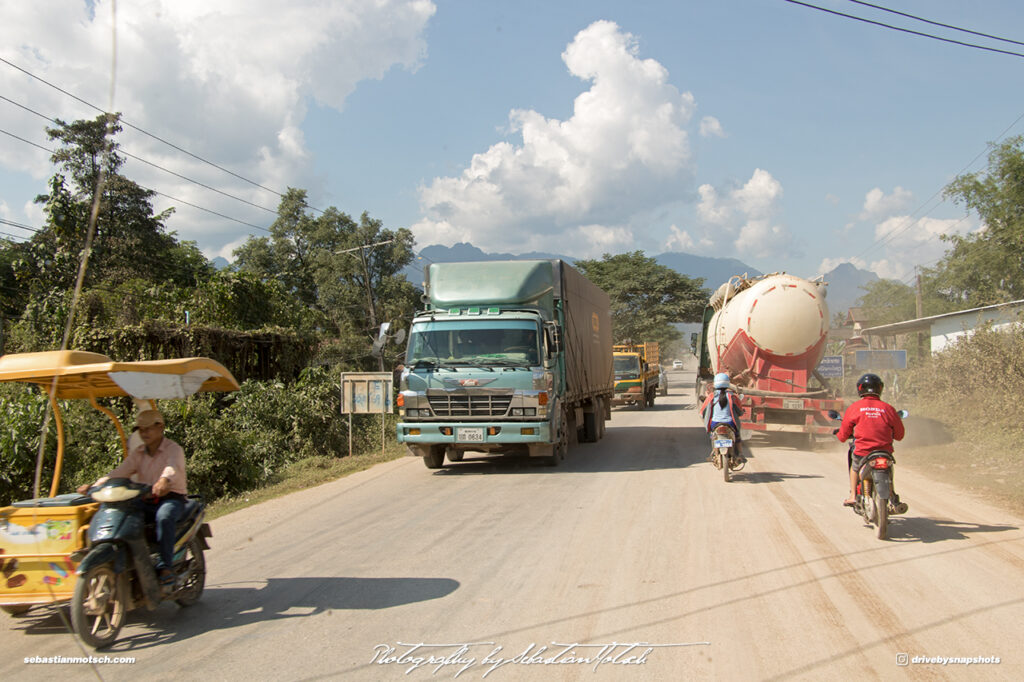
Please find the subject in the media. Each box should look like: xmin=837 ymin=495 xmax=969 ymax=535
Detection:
xmin=926 ymin=136 xmax=1024 ymax=308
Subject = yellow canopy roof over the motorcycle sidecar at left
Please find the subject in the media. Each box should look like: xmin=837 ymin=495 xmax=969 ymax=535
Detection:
xmin=0 ymin=350 xmax=239 ymax=399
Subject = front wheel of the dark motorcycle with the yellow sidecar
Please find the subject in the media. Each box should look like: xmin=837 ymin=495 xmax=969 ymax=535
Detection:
xmin=71 ymin=562 xmax=127 ymax=649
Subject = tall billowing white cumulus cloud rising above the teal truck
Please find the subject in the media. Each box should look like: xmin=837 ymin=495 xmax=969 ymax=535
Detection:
xmin=412 ymin=20 xmax=694 ymax=252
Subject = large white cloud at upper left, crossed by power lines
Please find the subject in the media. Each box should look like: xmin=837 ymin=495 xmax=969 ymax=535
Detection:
xmin=0 ymin=0 xmax=436 ymax=249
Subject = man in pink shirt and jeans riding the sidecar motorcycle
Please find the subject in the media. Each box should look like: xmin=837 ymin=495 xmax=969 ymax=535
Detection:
xmin=78 ymin=410 xmax=188 ymax=585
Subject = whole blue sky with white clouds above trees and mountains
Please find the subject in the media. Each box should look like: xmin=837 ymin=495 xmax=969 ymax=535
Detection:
xmin=0 ymin=0 xmax=1024 ymax=279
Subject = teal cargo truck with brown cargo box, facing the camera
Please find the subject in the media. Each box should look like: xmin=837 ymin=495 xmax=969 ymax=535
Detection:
xmin=397 ymin=260 xmax=614 ymax=469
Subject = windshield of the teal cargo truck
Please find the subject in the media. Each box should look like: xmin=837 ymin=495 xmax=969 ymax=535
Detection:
xmin=406 ymin=319 xmax=541 ymax=368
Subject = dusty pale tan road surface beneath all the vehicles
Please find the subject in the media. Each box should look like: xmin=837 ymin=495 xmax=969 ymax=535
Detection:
xmin=6 ymin=364 xmax=1024 ymax=681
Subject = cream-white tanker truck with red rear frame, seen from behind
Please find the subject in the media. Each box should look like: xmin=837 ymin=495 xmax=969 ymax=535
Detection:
xmin=695 ymin=272 xmax=844 ymax=445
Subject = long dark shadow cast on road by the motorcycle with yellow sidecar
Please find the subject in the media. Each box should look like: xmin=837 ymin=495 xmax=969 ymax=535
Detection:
xmin=4 ymin=578 xmax=459 ymax=653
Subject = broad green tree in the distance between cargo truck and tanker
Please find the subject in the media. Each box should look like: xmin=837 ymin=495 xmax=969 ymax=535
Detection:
xmin=575 ymin=251 xmax=710 ymax=346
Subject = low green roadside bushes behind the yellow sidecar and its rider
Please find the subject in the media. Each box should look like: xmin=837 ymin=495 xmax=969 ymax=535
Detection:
xmin=0 ymin=368 xmax=394 ymax=505
